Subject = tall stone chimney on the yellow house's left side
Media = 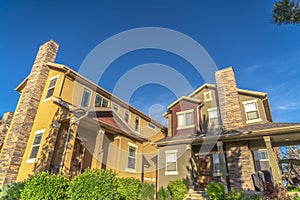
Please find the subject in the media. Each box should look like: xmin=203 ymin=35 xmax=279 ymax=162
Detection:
xmin=0 ymin=40 xmax=59 ymax=186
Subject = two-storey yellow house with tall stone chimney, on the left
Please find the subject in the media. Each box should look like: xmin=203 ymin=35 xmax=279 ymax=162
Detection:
xmin=0 ymin=40 xmax=167 ymax=186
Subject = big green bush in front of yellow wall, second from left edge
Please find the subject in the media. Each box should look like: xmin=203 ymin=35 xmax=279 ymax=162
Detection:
xmin=21 ymin=172 xmax=69 ymax=200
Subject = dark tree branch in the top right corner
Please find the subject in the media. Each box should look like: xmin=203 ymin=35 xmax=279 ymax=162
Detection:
xmin=272 ymin=0 xmax=300 ymax=25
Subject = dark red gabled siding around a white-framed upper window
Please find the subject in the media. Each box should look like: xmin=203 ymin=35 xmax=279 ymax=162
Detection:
xmin=171 ymin=99 xmax=201 ymax=136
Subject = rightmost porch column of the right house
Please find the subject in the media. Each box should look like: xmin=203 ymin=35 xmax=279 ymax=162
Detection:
xmin=264 ymin=136 xmax=282 ymax=184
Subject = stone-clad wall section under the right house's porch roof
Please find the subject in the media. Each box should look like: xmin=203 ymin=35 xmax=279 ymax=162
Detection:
xmin=225 ymin=141 xmax=254 ymax=190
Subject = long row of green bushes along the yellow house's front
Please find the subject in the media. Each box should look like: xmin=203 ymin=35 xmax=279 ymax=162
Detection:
xmin=0 ymin=169 xmax=155 ymax=200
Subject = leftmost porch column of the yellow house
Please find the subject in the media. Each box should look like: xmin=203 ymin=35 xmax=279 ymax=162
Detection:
xmin=61 ymin=119 xmax=78 ymax=176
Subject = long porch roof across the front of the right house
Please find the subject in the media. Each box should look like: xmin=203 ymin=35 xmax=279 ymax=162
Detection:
xmin=157 ymin=122 xmax=300 ymax=146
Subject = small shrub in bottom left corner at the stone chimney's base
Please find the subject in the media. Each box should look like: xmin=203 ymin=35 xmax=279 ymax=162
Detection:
xmin=0 ymin=182 xmax=25 ymax=200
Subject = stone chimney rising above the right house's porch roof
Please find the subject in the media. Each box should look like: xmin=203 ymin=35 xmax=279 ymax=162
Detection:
xmin=215 ymin=67 xmax=244 ymax=130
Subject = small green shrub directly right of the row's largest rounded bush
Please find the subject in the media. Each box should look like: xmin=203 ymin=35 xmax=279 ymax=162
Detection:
xmin=117 ymin=178 xmax=141 ymax=200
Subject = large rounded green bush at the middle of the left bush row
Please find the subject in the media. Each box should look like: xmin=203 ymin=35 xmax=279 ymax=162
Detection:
xmin=69 ymin=169 xmax=118 ymax=200
